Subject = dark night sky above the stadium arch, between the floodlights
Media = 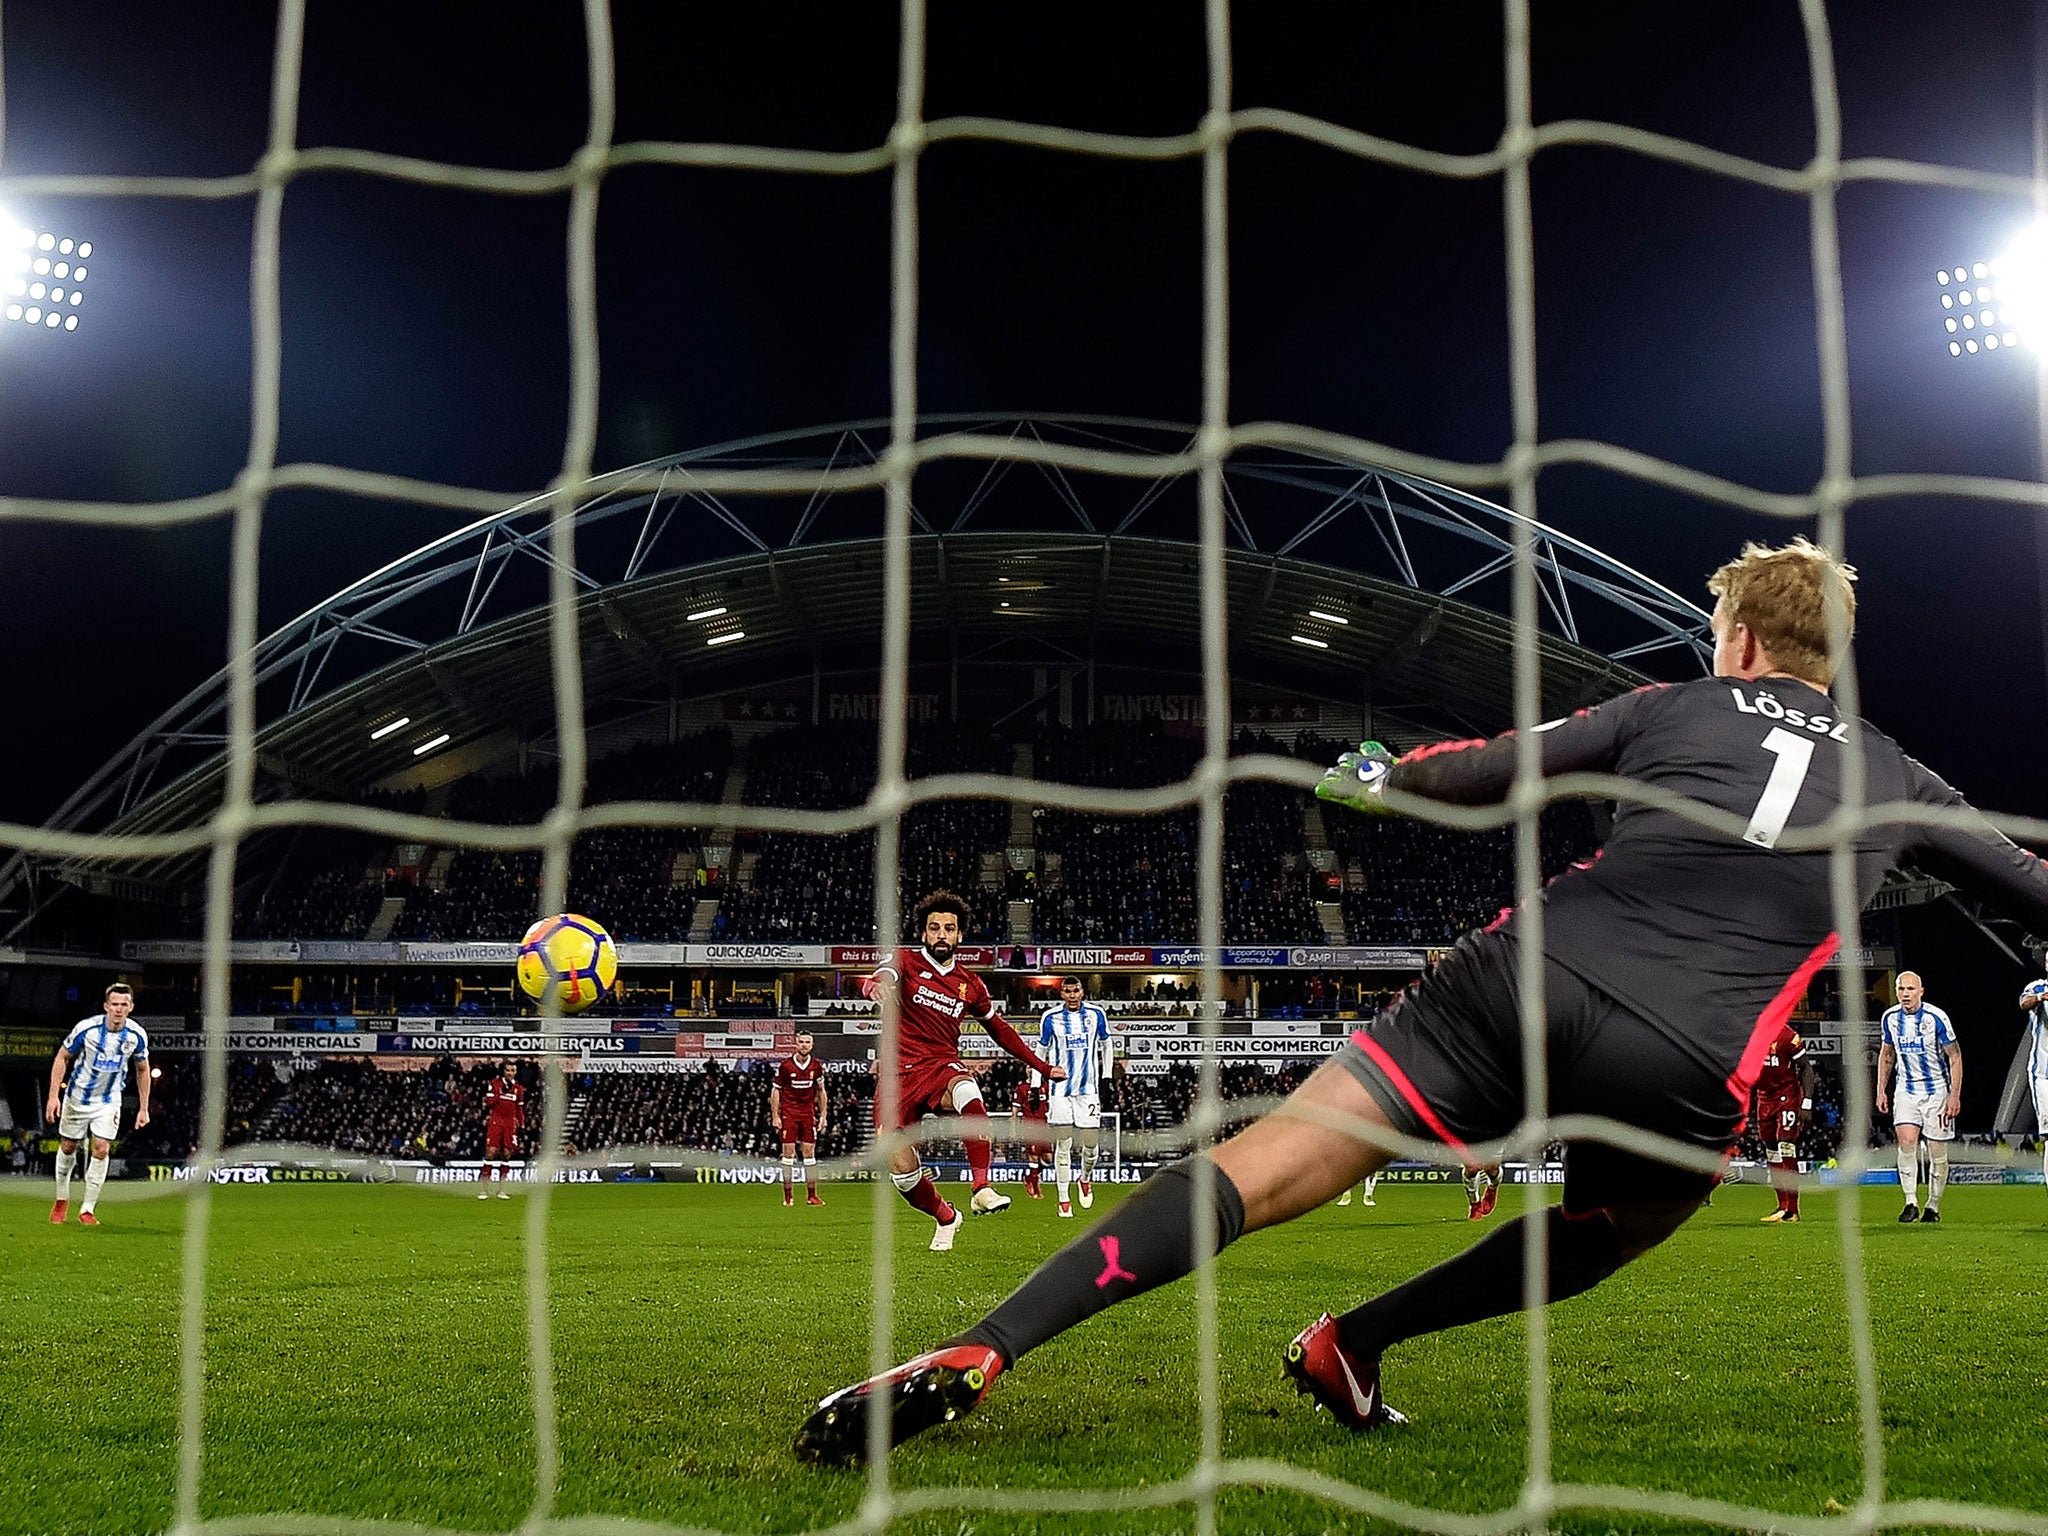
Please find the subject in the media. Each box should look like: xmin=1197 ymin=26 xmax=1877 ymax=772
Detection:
xmin=0 ymin=0 xmax=2048 ymax=1064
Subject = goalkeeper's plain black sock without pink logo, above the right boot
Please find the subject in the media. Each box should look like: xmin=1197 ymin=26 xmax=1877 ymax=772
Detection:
xmin=1337 ymin=1206 xmax=1622 ymax=1360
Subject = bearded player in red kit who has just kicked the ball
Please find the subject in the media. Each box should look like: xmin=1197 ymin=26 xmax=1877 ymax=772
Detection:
xmin=860 ymin=891 xmax=1067 ymax=1253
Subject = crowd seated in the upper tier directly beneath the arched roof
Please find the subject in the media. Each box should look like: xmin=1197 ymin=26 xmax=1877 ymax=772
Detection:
xmin=220 ymin=723 xmax=1595 ymax=958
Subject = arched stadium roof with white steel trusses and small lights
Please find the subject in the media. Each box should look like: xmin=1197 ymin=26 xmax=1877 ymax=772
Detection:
xmin=0 ymin=416 xmax=1710 ymax=933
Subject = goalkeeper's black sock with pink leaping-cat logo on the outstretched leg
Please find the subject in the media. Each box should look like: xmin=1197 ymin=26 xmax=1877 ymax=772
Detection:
xmin=950 ymin=1157 xmax=1245 ymax=1364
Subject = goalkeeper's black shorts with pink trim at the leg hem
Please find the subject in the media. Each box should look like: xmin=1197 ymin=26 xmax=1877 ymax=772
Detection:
xmin=1337 ymin=932 xmax=1749 ymax=1214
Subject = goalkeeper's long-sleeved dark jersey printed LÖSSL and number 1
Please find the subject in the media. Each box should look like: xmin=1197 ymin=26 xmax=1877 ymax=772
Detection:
xmin=1386 ymin=678 xmax=2048 ymax=1061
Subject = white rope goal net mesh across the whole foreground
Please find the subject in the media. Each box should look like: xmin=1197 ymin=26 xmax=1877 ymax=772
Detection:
xmin=0 ymin=0 xmax=2048 ymax=1536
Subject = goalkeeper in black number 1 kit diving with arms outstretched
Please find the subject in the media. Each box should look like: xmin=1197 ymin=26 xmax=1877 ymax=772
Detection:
xmin=797 ymin=539 xmax=2048 ymax=1460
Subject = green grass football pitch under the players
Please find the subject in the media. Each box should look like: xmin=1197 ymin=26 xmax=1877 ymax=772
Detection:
xmin=0 ymin=1182 xmax=2048 ymax=1536
